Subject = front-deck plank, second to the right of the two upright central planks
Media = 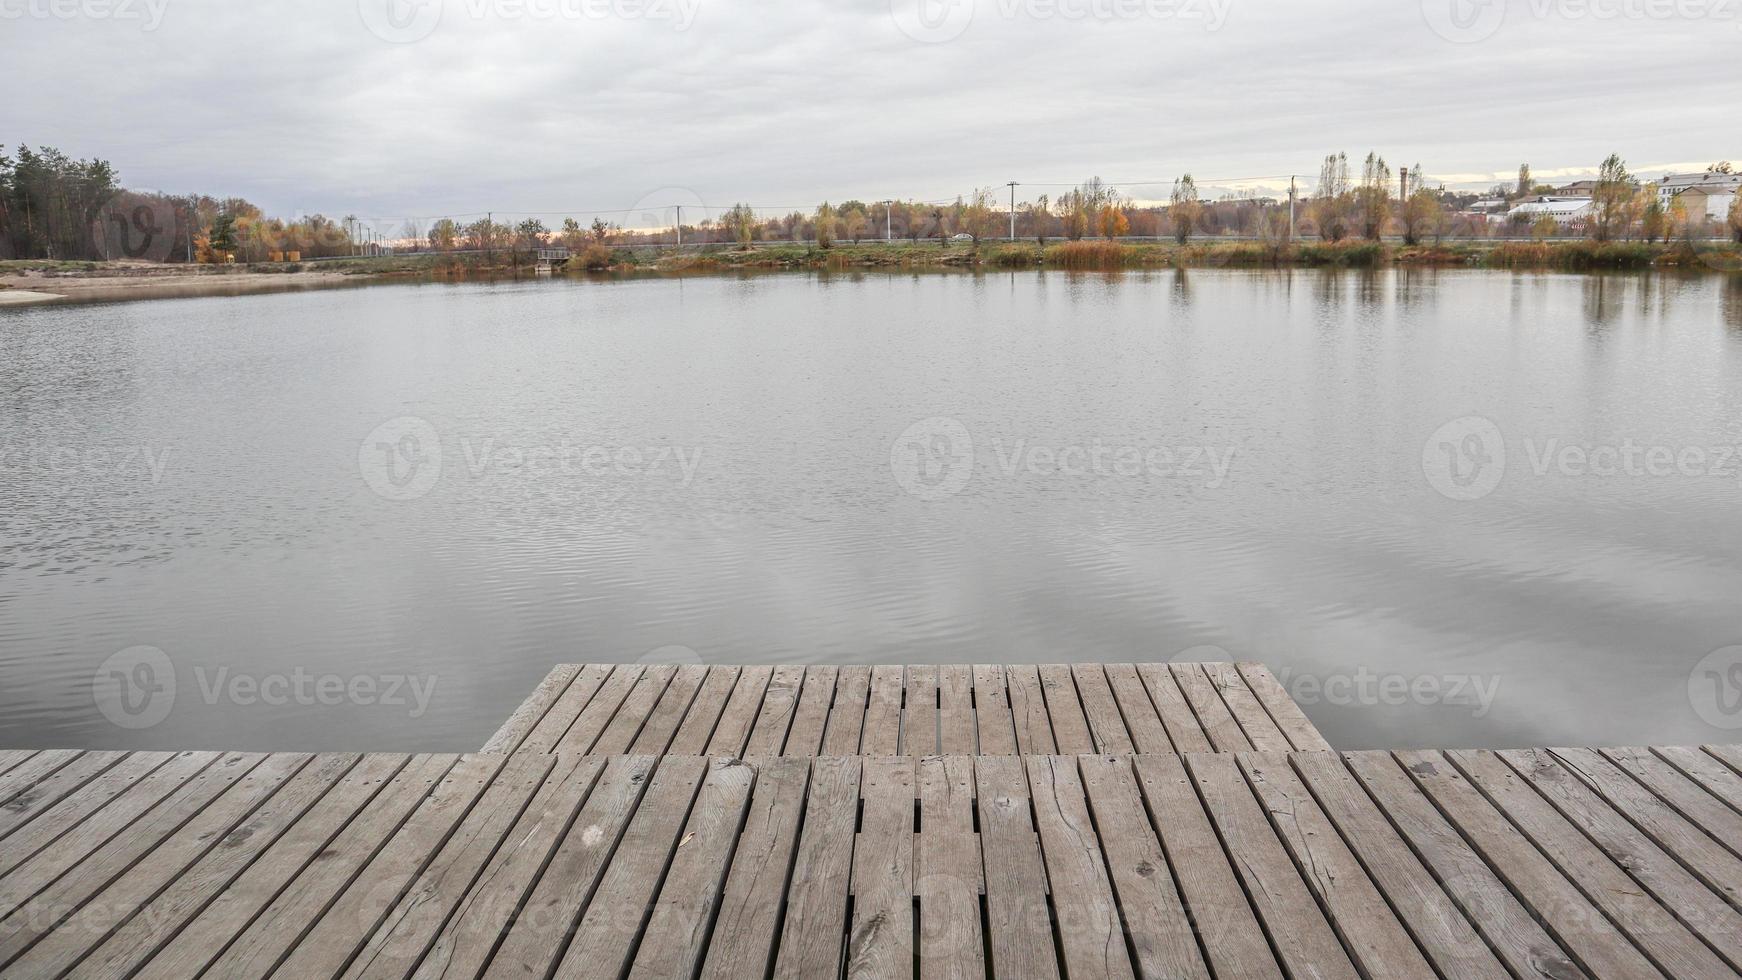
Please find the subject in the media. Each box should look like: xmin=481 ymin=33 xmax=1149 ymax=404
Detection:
xmin=1024 ymin=755 xmax=1134 ymax=980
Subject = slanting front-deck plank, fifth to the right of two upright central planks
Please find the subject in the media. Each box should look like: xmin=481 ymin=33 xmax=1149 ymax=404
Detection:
xmin=1184 ymin=752 xmax=1359 ymax=980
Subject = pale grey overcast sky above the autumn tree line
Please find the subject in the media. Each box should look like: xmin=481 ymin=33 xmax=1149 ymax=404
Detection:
xmin=0 ymin=0 xmax=1742 ymax=223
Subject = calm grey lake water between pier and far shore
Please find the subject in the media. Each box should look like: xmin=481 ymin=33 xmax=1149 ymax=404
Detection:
xmin=0 ymin=270 xmax=1742 ymax=750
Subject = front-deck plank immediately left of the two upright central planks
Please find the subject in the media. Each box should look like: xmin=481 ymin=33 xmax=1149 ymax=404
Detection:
xmin=773 ymin=755 xmax=859 ymax=980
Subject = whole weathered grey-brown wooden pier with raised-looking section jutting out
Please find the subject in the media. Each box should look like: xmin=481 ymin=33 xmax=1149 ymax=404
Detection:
xmin=0 ymin=665 xmax=1742 ymax=980
